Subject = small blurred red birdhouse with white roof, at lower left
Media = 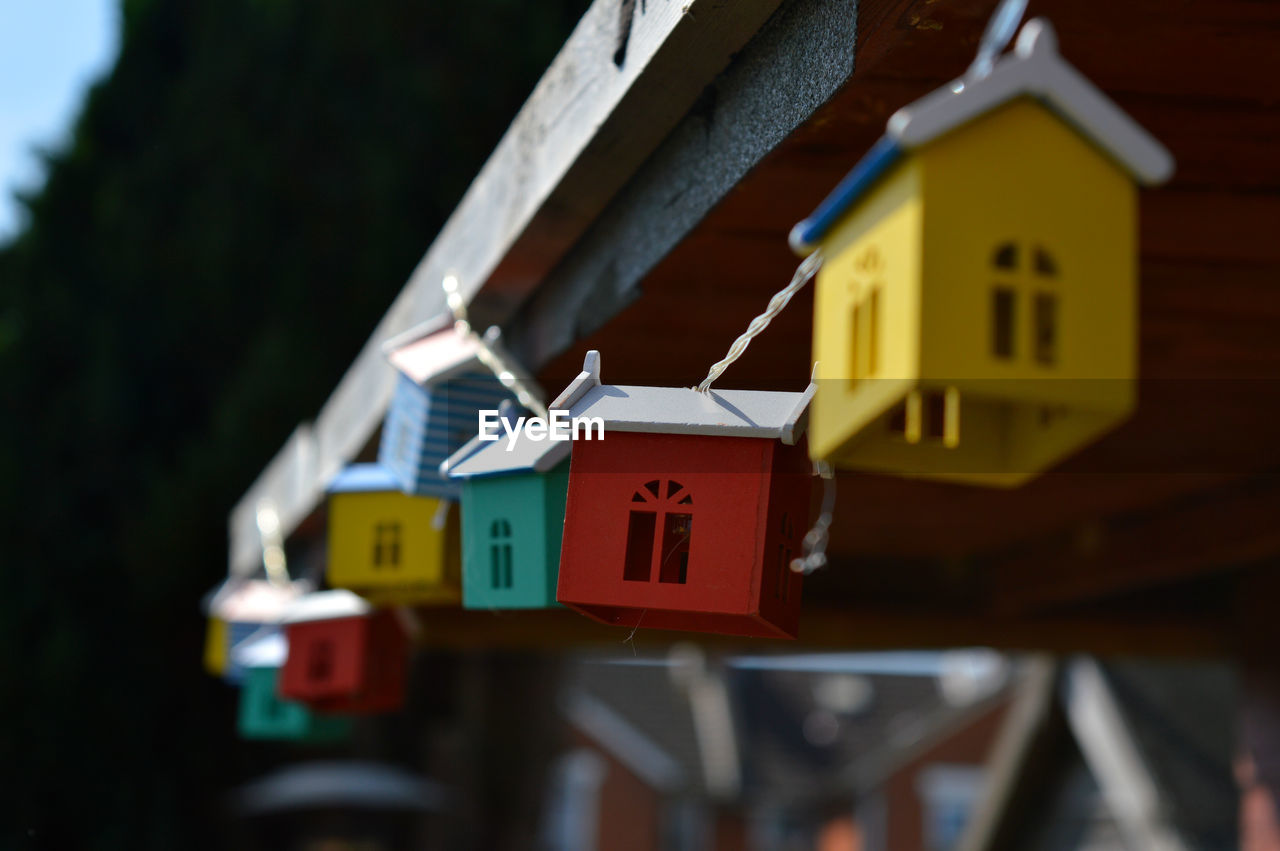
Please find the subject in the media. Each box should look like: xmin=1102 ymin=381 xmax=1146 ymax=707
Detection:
xmin=279 ymin=590 xmax=408 ymax=715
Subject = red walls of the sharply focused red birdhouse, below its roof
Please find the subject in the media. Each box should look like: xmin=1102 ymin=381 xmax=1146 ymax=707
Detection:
xmin=557 ymin=431 xmax=810 ymax=637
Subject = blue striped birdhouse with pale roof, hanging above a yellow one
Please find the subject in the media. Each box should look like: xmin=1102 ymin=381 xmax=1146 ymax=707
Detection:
xmin=378 ymin=317 xmax=527 ymax=499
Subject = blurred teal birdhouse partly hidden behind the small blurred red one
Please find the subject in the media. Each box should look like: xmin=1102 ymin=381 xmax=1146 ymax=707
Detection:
xmin=234 ymin=630 xmax=351 ymax=744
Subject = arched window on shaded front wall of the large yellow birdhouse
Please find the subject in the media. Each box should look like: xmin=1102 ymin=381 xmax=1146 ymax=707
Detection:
xmin=991 ymin=242 xmax=1059 ymax=366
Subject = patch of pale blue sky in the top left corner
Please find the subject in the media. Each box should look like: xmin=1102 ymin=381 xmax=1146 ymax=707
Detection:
xmin=0 ymin=0 xmax=120 ymax=241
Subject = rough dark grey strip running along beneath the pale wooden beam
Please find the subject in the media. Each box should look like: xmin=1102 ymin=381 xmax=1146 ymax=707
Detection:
xmin=511 ymin=0 xmax=856 ymax=371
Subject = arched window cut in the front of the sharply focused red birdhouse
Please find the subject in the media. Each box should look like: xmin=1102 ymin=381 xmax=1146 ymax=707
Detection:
xmin=622 ymin=479 xmax=694 ymax=585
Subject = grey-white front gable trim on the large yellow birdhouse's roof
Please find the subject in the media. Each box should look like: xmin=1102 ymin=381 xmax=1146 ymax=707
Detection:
xmin=887 ymin=18 xmax=1174 ymax=184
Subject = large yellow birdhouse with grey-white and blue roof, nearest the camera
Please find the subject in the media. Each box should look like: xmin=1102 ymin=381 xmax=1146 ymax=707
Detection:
xmin=791 ymin=19 xmax=1172 ymax=486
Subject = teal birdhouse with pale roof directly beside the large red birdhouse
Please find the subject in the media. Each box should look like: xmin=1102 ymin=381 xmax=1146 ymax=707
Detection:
xmin=440 ymin=406 xmax=572 ymax=609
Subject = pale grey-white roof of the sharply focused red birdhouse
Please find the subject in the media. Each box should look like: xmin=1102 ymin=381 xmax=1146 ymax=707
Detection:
xmin=552 ymin=351 xmax=817 ymax=444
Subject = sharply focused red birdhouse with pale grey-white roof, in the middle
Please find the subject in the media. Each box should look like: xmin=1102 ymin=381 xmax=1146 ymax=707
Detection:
xmin=552 ymin=352 xmax=814 ymax=639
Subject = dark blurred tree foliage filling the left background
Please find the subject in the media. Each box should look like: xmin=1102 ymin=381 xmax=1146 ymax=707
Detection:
xmin=0 ymin=0 xmax=586 ymax=848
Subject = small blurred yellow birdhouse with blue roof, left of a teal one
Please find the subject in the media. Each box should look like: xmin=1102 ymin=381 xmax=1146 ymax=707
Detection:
xmin=328 ymin=465 xmax=462 ymax=605
